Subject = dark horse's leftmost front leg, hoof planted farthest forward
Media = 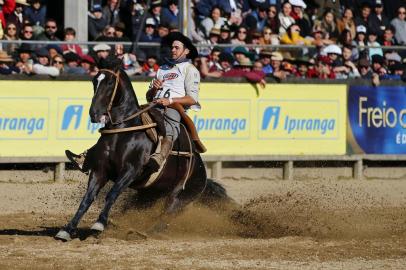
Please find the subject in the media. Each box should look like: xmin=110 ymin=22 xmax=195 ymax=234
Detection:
xmin=55 ymin=171 xmax=107 ymax=241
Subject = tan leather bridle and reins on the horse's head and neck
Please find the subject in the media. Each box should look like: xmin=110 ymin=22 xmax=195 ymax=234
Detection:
xmin=99 ymin=69 xmax=156 ymax=134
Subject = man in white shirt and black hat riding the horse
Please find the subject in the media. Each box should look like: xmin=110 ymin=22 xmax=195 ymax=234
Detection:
xmin=65 ymin=32 xmax=200 ymax=172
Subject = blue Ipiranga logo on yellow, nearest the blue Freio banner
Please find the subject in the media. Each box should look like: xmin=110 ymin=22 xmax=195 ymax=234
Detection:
xmin=259 ymin=101 xmax=338 ymax=139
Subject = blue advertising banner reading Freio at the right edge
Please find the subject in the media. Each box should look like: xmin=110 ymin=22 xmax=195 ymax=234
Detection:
xmin=347 ymin=86 xmax=406 ymax=154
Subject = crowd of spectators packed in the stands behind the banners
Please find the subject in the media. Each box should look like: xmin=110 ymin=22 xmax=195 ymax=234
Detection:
xmin=0 ymin=0 xmax=406 ymax=85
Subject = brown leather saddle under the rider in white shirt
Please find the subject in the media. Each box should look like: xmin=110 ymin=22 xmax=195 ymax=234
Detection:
xmin=141 ymin=103 xmax=207 ymax=153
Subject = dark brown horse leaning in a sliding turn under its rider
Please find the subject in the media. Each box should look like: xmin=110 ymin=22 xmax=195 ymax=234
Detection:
xmin=55 ymin=58 xmax=228 ymax=241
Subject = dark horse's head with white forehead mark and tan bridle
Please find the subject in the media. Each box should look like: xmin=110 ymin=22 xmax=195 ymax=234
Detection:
xmin=89 ymin=59 xmax=138 ymax=124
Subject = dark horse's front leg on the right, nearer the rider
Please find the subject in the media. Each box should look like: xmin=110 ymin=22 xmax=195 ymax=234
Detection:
xmin=91 ymin=168 xmax=139 ymax=232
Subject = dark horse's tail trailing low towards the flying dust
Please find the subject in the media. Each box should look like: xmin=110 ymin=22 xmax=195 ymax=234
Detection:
xmin=199 ymin=178 xmax=236 ymax=206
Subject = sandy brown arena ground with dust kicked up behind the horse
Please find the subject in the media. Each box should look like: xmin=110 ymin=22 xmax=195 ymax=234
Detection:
xmin=0 ymin=176 xmax=406 ymax=270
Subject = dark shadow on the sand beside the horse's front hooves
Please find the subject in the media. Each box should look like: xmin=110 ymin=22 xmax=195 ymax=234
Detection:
xmin=0 ymin=227 xmax=97 ymax=241
